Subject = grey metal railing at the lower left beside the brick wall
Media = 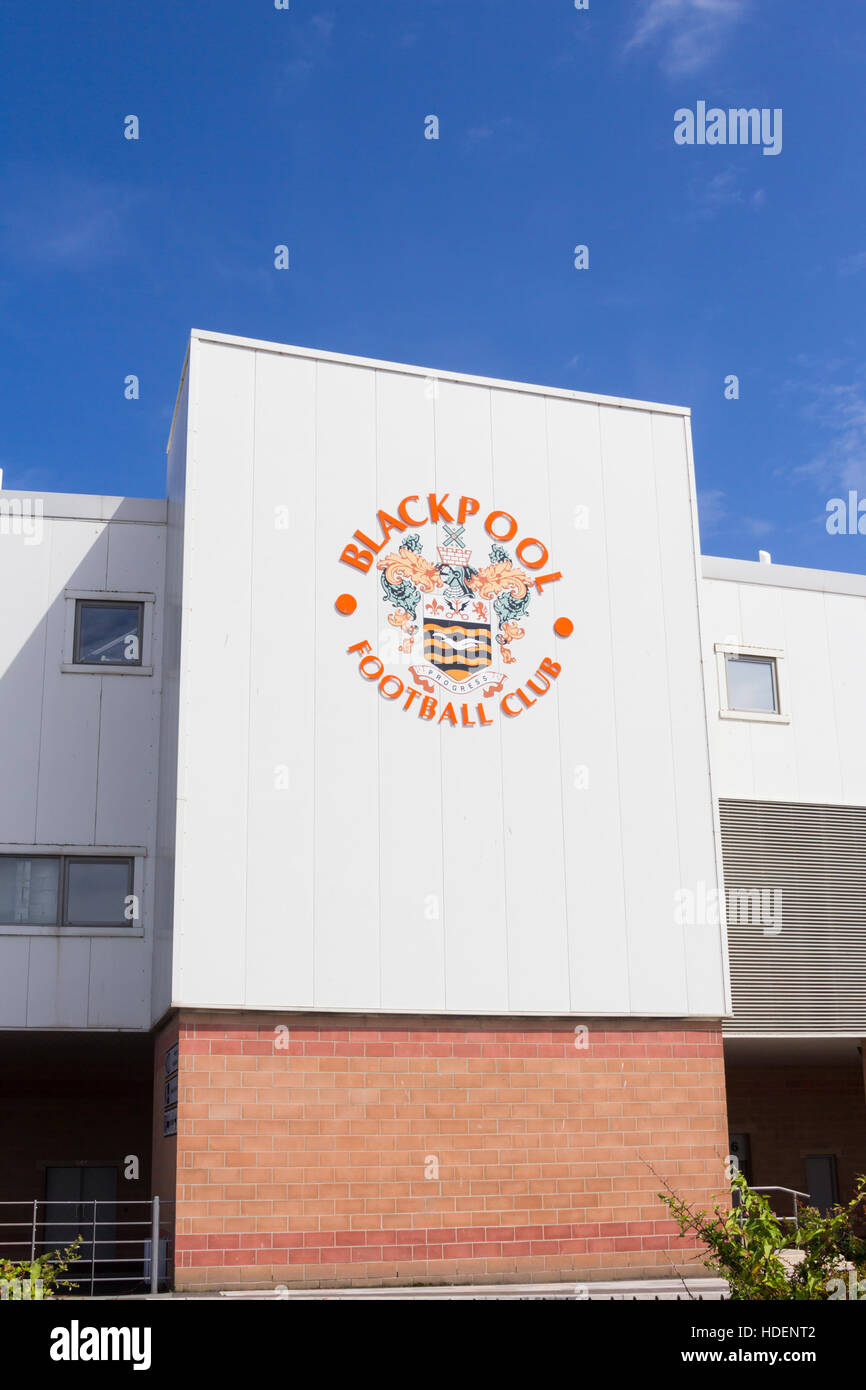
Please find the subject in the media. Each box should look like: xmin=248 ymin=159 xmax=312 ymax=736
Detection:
xmin=0 ymin=1197 xmax=174 ymax=1297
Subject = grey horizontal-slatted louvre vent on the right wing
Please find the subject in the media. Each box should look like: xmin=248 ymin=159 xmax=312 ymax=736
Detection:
xmin=719 ymin=801 xmax=866 ymax=1037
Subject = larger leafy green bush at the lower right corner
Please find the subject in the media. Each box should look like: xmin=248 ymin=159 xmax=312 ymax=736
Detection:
xmin=659 ymin=1175 xmax=866 ymax=1302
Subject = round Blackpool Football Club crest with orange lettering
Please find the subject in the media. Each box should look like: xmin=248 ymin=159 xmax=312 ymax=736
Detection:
xmin=334 ymin=492 xmax=574 ymax=728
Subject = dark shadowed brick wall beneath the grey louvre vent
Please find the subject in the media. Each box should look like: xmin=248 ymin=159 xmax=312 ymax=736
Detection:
xmin=727 ymin=1063 xmax=866 ymax=1209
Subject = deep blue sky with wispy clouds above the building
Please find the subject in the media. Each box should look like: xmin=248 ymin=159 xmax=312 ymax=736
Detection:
xmin=0 ymin=0 xmax=866 ymax=571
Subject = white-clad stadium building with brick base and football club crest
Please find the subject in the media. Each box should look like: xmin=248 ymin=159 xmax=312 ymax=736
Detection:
xmin=0 ymin=332 xmax=866 ymax=1291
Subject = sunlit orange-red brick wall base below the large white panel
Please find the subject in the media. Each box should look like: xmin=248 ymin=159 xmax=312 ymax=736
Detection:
xmin=167 ymin=1013 xmax=727 ymax=1289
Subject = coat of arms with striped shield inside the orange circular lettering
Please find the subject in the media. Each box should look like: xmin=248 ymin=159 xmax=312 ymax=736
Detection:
xmin=378 ymin=524 xmax=530 ymax=695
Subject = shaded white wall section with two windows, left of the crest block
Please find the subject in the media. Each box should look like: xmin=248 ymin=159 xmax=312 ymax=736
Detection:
xmin=0 ymin=491 xmax=165 ymax=1029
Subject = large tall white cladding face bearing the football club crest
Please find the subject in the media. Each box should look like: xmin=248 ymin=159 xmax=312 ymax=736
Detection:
xmin=172 ymin=336 xmax=726 ymax=1017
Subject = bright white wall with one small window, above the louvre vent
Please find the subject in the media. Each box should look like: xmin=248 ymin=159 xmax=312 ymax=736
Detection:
xmin=703 ymin=560 xmax=866 ymax=806
